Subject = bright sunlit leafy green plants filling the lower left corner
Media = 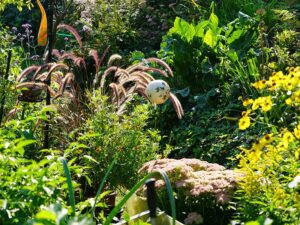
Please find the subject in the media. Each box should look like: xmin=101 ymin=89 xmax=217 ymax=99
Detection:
xmin=0 ymin=118 xmax=71 ymax=224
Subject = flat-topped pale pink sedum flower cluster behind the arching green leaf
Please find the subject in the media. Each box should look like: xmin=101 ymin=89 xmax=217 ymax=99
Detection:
xmin=140 ymin=158 xmax=240 ymax=204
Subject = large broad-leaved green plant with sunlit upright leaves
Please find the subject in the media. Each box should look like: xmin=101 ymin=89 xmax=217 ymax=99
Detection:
xmin=159 ymin=12 xmax=257 ymax=93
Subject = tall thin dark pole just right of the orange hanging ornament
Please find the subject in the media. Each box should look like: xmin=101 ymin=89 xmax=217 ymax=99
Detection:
xmin=44 ymin=0 xmax=54 ymax=148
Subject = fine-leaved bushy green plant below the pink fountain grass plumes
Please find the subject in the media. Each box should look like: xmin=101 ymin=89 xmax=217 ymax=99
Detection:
xmin=65 ymin=92 xmax=160 ymax=190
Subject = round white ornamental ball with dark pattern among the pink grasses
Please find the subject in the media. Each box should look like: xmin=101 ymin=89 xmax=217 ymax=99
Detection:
xmin=146 ymin=80 xmax=170 ymax=104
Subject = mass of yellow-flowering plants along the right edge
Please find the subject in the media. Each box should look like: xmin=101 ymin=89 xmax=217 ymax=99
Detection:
xmin=237 ymin=67 xmax=300 ymax=224
